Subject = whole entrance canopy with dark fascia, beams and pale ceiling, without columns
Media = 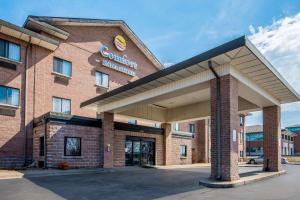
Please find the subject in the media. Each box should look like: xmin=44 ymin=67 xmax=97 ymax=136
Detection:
xmin=81 ymin=36 xmax=300 ymax=122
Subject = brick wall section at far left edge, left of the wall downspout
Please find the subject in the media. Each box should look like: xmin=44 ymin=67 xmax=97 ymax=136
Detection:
xmin=0 ymin=33 xmax=26 ymax=168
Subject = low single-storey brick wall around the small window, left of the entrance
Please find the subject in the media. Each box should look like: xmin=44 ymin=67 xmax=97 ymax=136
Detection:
xmin=33 ymin=122 xmax=102 ymax=168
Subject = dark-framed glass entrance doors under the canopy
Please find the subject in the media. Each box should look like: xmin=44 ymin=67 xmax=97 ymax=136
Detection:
xmin=125 ymin=136 xmax=155 ymax=166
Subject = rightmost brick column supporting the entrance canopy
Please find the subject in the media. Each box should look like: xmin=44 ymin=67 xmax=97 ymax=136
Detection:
xmin=263 ymin=106 xmax=281 ymax=172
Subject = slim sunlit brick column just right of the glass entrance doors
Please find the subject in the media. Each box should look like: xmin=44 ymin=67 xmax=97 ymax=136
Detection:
xmin=161 ymin=123 xmax=172 ymax=165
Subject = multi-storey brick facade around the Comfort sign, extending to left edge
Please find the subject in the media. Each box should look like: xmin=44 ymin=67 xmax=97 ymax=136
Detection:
xmin=0 ymin=23 xmax=158 ymax=167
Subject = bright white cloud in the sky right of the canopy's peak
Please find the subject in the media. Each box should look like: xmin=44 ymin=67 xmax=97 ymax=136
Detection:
xmin=249 ymin=13 xmax=300 ymax=112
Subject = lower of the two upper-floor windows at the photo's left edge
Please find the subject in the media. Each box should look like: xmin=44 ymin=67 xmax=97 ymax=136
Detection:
xmin=0 ymin=86 xmax=20 ymax=107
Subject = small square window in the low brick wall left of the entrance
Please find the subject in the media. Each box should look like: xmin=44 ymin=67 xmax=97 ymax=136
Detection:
xmin=64 ymin=137 xmax=81 ymax=156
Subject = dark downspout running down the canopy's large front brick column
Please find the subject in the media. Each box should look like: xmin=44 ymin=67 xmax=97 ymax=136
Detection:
xmin=208 ymin=60 xmax=222 ymax=179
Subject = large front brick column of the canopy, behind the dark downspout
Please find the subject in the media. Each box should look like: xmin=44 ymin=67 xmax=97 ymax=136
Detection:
xmin=210 ymin=75 xmax=240 ymax=181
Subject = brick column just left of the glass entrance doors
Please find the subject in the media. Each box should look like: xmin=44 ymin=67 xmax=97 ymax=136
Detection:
xmin=100 ymin=112 xmax=114 ymax=168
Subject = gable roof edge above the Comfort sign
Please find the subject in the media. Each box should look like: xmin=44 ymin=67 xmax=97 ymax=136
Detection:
xmin=23 ymin=15 xmax=163 ymax=69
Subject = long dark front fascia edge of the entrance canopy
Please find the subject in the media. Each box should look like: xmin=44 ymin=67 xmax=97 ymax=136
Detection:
xmin=80 ymin=36 xmax=246 ymax=107
